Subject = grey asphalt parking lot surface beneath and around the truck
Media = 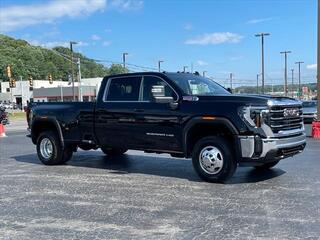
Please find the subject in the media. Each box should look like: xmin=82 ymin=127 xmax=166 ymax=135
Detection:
xmin=0 ymin=123 xmax=320 ymax=239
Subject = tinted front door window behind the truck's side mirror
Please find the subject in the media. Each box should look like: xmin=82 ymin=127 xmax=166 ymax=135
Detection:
xmin=142 ymin=76 xmax=177 ymax=102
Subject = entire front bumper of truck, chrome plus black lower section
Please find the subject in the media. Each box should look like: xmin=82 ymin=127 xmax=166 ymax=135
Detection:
xmin=239 ymin=132 xmax=306 ymax=165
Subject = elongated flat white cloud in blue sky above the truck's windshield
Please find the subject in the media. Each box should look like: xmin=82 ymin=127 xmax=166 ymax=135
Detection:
xmin=185 ymin=32 xmax=243 ymax=45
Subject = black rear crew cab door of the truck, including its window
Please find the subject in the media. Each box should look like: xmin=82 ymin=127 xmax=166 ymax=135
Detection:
xmin=95 ymin=76 xmax=142 ymax=148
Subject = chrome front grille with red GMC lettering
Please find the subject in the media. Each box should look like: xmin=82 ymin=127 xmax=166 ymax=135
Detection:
xmin=269 ymin=105 xmax=303 ymax=133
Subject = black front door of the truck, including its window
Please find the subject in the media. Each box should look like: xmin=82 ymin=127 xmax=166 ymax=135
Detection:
xmin=137 ymin=75 xmax=182 ymax=152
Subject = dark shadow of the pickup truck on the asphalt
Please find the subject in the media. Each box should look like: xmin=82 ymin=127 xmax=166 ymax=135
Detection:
xmin=13 ymin=151 xmax=285 ymax=184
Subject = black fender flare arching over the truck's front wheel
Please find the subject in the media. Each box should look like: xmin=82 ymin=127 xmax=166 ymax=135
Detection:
xmin=182 ymin=116 xmax=239 ymax=157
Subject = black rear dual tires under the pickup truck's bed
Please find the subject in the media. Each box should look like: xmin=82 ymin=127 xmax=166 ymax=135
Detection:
xmin=37 ymin=131 xmax=73 ymax=165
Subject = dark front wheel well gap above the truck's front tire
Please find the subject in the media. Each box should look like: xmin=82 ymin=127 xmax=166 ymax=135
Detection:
xmin=186 ymin=123 xmax=235 ymax=157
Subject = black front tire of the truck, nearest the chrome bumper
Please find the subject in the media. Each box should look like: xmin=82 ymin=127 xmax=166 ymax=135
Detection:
xmin=192 ymin=136 xmax=237 ymax=182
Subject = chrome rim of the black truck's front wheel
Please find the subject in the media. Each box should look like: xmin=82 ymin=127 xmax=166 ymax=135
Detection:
xmin=199 ymin=146 xmax=223 ymax=174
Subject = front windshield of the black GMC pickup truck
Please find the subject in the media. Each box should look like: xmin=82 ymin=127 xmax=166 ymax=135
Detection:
xmin=167 ymin=73 xmax=230 ymax=96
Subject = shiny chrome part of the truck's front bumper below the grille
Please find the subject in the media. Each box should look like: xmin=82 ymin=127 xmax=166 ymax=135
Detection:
xmin=239 ymin=132 xmax=306 ymax=159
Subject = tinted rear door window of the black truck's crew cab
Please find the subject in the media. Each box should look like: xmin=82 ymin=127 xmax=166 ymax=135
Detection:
xmin=107 ymin=77 xmax=141 ymax=101
